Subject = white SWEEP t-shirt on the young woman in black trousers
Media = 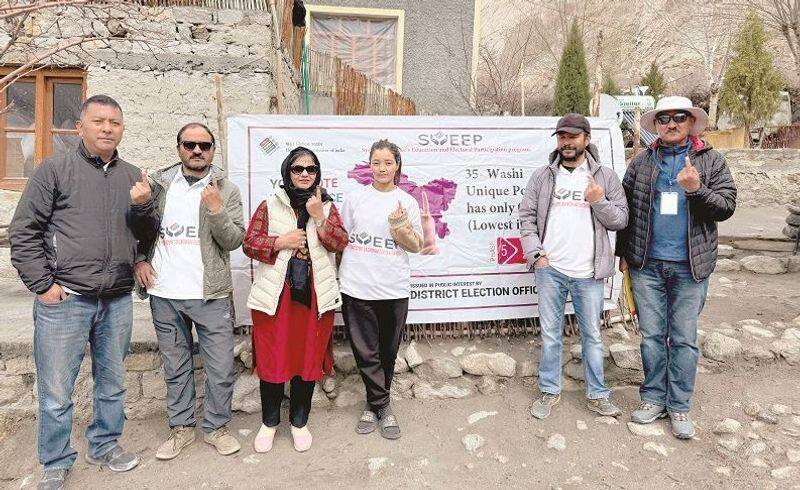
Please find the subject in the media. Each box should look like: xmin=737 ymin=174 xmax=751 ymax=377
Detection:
xmin=339 ymin=185 xmax=422 ymax=300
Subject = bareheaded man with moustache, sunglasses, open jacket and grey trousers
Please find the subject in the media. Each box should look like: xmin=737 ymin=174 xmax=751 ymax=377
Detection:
xmin=134 ymin=123 xmax=244 ymax=460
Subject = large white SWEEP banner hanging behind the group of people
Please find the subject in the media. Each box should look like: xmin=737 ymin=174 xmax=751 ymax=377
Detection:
xmin=227 ymin=116 xmax=625 ymax=324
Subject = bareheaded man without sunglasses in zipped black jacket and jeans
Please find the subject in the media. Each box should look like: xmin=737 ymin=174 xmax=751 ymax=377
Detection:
xmin=9 ymin=95 xmax=159 ymax=489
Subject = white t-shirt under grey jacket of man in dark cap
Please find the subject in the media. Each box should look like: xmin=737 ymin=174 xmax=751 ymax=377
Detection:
xmin=542 ymin=162 xmax=594 ymax=279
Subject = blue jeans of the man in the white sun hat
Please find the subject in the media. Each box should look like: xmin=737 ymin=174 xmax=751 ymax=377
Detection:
xmin=631 ymin=259 xmax=708 ymax=412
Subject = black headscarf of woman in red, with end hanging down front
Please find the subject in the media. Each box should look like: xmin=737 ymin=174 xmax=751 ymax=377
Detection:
xmin=281 ymin=146 xmax=333 ymax=307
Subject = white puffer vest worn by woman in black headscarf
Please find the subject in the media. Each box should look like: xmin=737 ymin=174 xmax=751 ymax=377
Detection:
xmin=247 ymin=189 xmax=342 ymax=316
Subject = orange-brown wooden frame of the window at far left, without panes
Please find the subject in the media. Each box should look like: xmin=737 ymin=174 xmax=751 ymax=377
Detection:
xmin=0 ymin=66 xmax=86 ymax=191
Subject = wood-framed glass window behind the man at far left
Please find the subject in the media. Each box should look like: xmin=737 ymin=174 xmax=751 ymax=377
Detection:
xmin=0 ymin=69 xmax=86 ymax=189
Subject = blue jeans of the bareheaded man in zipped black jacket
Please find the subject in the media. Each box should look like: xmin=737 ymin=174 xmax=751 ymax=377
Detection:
xmin=33 ymin=294 xmax=133 ymax=469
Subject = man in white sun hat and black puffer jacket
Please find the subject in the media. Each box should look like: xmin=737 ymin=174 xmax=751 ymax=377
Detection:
xmin=616 ymin=97 xmax=736 ymax=439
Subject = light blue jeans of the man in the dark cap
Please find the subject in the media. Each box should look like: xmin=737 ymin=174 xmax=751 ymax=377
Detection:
xmin=535 ymin=266 xmax=610 ymax=400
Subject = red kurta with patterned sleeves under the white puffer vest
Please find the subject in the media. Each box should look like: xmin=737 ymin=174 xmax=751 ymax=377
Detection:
xmin=242 ymin=202 xmax=347 ymax=383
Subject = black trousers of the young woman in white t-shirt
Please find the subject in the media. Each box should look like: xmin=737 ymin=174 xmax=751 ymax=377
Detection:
xmin=342 ymin=294 xmax=408 ymax=413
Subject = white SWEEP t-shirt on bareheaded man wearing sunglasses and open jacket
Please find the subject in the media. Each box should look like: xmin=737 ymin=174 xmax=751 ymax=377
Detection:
xmin=147 ymin=172 xmax=211 ymax=299
